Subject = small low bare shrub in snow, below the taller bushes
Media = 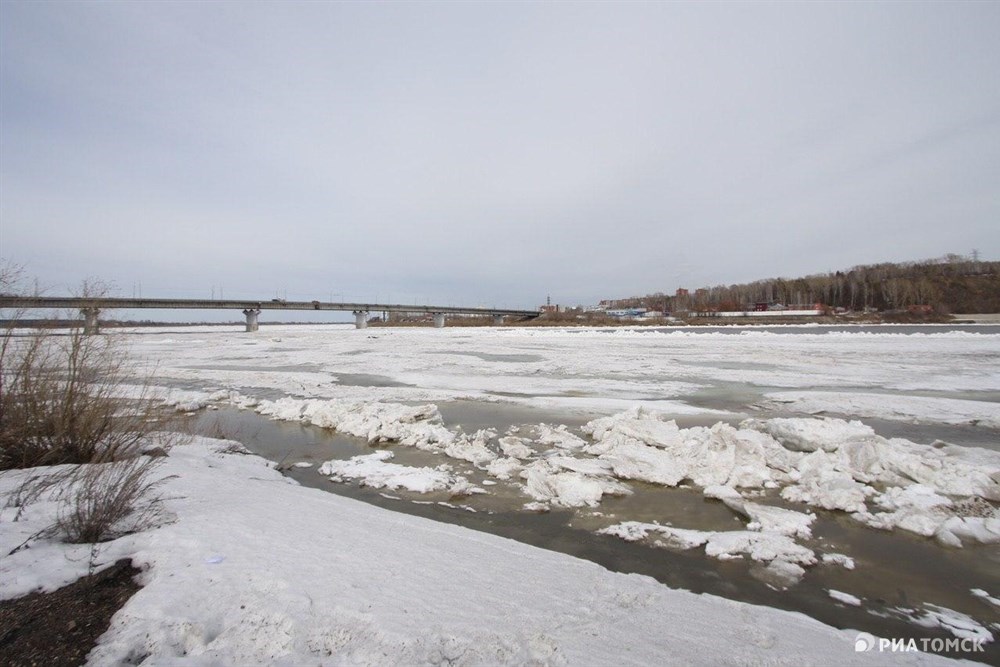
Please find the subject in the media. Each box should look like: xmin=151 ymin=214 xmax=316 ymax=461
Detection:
xmin=56 ymin=456 xmax=164 ymax=544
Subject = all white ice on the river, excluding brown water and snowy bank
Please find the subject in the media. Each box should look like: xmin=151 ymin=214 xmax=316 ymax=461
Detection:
xmin=7 ymin=326 xmax=1000 ymax=660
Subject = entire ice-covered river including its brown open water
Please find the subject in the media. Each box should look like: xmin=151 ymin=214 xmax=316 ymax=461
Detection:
xmin=123 ymin=325 xmax=1000 ymax=660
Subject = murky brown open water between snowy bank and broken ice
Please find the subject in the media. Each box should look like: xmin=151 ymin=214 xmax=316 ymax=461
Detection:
xmin=186 ymin=402 xmax=1000 ymax=664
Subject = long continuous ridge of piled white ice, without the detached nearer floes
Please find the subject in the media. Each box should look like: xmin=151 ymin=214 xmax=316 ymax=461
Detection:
xmin=257 ymin=398 xmax=1000 ymax=547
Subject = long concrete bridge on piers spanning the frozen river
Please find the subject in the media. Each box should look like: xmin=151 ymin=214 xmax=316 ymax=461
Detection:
xmin=0 ymin=295 xmax=539 ymax=333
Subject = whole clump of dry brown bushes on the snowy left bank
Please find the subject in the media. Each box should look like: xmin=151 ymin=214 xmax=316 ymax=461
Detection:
xmin=0 ymin=267 xmax=177 ymax=551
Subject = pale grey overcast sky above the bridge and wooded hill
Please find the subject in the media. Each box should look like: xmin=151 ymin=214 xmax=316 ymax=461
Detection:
xmin=0 ymin=0 xmax=1000 ymax=318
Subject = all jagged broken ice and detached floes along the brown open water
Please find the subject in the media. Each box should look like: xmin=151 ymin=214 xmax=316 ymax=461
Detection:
xmin=154 ymin=386 xmax=1000 ymax=642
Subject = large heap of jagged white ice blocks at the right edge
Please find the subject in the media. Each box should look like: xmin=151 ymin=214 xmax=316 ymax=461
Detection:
xmin=583 ymin=409 xmax=1000 ymax=546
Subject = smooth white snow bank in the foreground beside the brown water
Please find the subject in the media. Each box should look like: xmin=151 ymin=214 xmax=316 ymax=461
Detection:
xmin=0 ymin=439 xmax=960 ymax=665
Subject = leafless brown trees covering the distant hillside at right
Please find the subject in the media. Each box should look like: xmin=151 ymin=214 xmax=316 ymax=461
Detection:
xmin=602 ymin=254 xmax=1000 ymax=313
